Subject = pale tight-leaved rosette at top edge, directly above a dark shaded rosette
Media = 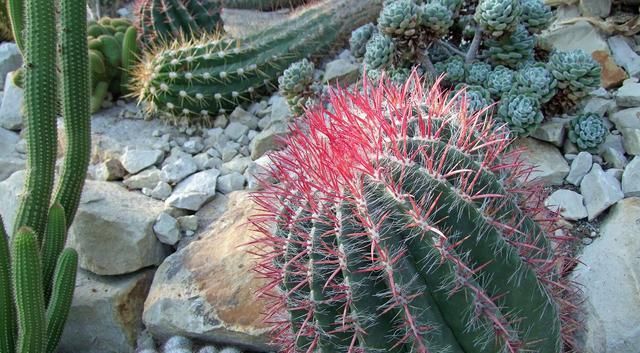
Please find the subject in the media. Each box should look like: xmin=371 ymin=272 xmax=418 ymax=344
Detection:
xmin=474 ymin=0 xmax=522 ymax=37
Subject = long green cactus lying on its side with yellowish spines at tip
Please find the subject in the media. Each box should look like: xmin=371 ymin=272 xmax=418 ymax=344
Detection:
xmin=133 ymin=0 xmax=380 ymax=124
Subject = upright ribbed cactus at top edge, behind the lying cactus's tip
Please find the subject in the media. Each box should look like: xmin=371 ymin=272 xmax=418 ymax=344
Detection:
xmin=136 ymin=0 xmax=222 ymax=46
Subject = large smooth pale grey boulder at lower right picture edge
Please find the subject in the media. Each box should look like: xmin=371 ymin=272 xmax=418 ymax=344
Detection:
xmin=574 ymin=197 xmax=640 ymax=353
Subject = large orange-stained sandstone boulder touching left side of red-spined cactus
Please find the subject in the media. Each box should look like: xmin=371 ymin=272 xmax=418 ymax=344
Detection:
xmin=143 ymin=192 xmax=272 ymax=351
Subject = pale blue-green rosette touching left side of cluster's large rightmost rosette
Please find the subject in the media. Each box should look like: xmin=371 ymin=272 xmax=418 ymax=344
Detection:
xmin=513 ymin=63 xmax=558 ymax=104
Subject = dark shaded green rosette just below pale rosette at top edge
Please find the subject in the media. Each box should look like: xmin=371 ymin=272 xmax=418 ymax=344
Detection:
xmin=484 ymin=25 xmax=536 ymax=69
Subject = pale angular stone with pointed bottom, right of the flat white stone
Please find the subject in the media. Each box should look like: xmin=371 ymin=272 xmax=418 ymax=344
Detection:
xmin=580 ymin=164 xmax=624 ymax=221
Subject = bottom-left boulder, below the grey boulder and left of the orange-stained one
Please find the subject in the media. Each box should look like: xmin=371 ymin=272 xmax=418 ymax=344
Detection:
xmin=58 ymin=270 xmax=153 ymax=353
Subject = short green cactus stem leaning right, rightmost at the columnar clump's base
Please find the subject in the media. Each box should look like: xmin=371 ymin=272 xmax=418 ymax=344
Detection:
xmin=46 ymin=248 xmax=78 ymax=353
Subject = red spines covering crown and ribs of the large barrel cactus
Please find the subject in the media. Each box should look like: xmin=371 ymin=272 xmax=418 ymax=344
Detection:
xmin=252 ymin=72 xmax=576 ymax=353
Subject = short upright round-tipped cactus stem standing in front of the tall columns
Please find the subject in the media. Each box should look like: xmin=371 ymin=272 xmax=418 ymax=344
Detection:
xmin=11 ymin=226 xmax=46 ymax=353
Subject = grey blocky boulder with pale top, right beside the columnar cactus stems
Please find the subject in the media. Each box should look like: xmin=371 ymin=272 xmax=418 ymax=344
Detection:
xmin=68 ymin=180 xmax=166 ymax=275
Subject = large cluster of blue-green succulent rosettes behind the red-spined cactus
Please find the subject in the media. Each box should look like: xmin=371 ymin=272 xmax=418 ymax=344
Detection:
xmin=350 ymin=0 xmax=600 ymax=135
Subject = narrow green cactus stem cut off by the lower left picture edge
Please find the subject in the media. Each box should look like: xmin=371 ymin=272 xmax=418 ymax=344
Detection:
xmin=0 ymin=216 xmax=16 ymax=353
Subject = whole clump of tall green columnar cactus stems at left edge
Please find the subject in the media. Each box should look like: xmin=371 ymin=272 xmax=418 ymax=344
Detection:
xmin=0 ymin=0 xmax=91 ymax=353
